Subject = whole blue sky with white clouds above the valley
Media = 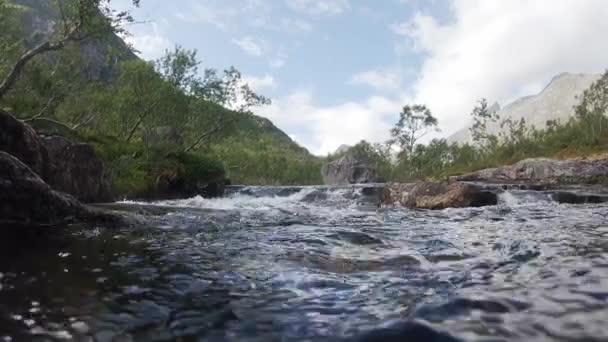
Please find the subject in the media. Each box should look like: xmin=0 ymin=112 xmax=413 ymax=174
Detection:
xmin=112 ymin=0 xmax=608 ymax=155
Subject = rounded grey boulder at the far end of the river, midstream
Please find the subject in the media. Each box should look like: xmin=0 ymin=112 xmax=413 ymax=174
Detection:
xmin=321 ymin=154 xmax=378 ymax=185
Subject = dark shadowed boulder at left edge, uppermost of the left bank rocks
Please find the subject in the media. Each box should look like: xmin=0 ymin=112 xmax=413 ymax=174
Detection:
xmin=0 ymin=110 xmax=47 ymax=176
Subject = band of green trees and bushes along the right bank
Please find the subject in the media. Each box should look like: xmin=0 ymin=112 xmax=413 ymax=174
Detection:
xmin=329 ymin=71 xmax=608 ymax=181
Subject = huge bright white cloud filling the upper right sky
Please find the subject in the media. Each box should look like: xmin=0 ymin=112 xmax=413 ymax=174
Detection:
xmin=392 ymin=0 xmax=608 ymax=134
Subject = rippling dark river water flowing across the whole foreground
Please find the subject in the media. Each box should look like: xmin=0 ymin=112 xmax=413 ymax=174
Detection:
xmin=0 ymin=187 xmax=608 ymax=342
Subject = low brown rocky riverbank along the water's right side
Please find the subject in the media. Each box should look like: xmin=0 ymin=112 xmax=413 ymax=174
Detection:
xmin=382 ymin=158 xmax=608 ymax=209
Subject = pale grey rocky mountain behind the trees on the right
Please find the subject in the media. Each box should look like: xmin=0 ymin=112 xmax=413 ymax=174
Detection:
xmin=448 ymin=73 xmax=600 ymax=143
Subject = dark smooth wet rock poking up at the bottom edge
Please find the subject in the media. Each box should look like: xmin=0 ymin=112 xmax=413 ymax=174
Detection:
xmin=353 ymin=321 xmax=461 ymax=342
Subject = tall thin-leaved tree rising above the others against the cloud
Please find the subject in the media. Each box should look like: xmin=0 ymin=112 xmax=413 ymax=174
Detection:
xmin=388 ymin=105 xmax=439 ymax=155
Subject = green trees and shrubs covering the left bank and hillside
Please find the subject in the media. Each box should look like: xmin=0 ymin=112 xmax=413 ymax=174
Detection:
xmin=0 ymin=0 xmax=321 ymax=197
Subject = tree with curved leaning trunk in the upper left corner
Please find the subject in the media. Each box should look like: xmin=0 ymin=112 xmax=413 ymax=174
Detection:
xmin=0 ymin=0 xmax=140 ymax=99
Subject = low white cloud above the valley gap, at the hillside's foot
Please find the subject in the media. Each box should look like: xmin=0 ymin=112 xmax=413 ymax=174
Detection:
xmin=257 ymin=90 xmax=400 ymax=155
